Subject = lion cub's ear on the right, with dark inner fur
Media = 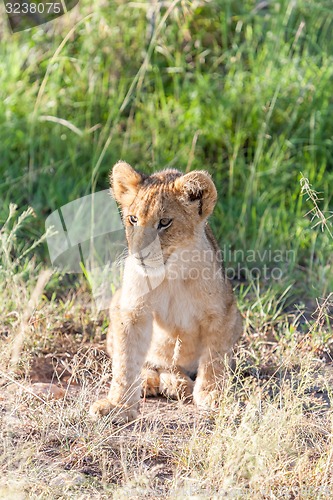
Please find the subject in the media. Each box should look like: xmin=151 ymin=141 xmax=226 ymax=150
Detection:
xmin=175 ymin=170 xmax=217 ymax=218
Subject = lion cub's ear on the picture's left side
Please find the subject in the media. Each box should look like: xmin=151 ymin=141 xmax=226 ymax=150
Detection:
xmin=110 ymin=161 xmax=144 ymax=206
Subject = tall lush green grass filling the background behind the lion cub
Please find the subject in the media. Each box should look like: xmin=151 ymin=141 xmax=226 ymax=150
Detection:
xmin=0 ymin=1 xmax=333 ymax=296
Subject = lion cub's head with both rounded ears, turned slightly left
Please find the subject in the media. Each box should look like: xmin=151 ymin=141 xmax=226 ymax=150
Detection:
xmin=110 ymin=161 xmax=217 ymax=274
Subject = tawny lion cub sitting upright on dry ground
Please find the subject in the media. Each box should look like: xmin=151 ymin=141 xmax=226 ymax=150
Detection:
xmin=90 ymin=161 xmax=242 ymax=420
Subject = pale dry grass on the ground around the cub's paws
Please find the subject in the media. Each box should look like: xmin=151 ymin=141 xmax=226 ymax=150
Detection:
xmin=0 ymin=282 xmax=333 ymax=499
